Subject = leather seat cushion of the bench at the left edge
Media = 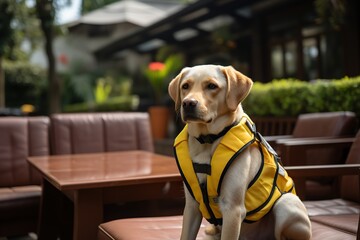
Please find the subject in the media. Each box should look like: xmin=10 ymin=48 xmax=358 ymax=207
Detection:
xmin=0 ymin=185 xmax=41 ymax=221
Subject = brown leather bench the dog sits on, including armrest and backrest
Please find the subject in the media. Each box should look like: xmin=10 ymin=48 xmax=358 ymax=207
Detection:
xmin=98 ymin=131 xmax=360 ymax=240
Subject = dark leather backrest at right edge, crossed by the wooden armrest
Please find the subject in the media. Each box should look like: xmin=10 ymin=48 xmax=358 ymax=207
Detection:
xmin=341 ymin=130 xmax=360 ymax=202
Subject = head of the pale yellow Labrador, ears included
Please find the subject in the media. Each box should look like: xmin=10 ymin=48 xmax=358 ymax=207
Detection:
xmin=168 ymin=65 xmax=253 ymax=123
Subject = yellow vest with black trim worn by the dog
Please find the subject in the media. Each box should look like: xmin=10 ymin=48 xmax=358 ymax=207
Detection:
xmin=174 ymin=116 xmax=295 ymax=225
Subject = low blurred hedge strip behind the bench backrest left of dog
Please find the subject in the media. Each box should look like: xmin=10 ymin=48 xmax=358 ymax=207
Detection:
xmin=63 ymin=95 xmax=139 ymax=112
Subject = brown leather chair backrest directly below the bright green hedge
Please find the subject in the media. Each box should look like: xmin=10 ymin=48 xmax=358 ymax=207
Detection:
xmin=293 ymin=112 xmax=357 ymax=138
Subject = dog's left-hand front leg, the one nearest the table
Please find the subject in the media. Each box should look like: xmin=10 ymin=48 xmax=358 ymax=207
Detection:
xmin=180 ymin=187 xmax=202 ymax=240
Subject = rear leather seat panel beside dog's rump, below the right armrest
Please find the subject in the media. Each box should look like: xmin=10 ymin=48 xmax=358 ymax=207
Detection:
xmin=304 ymin=199 xmax=360 ymax=217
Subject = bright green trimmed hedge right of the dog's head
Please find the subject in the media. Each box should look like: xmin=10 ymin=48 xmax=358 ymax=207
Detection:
xmin=243 ymin=76 xmax=360 ymax=117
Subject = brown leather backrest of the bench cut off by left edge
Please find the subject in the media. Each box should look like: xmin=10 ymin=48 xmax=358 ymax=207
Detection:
xmin=0 ymin=117 xmax=49 ymax=187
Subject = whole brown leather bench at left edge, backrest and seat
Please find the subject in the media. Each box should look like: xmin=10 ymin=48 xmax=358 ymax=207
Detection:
xmin=0 ymin=117 xmax=49 ymax=237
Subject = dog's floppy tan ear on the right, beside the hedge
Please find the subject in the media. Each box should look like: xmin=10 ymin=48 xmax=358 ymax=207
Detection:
xmin=222 ymin=66 xmax=253 ymax=111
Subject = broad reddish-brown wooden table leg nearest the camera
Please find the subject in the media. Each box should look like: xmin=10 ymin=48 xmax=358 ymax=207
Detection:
xmin=73 ymin=189 xmax=103 ymax=240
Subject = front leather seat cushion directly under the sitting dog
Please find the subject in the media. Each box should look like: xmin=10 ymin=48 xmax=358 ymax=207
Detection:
xmin=98 ymin=214 xmax=358 ymax=240
